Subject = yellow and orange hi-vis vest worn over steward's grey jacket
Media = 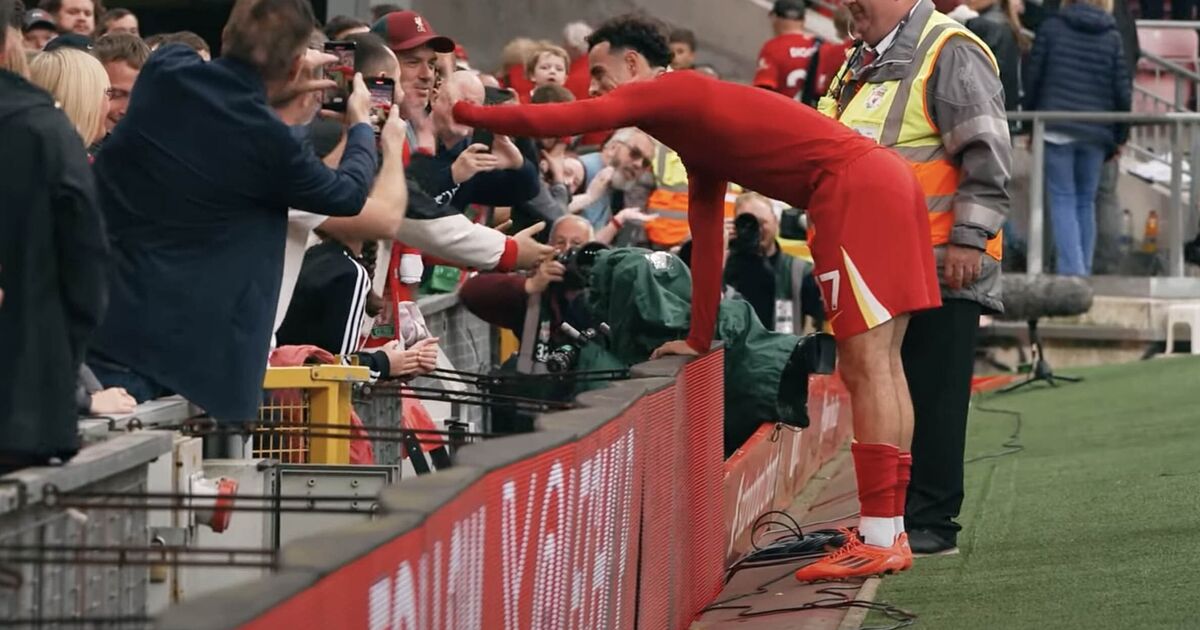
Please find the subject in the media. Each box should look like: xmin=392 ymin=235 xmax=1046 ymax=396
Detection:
xmin=817 ymin=12 xmax=1003 ymax=260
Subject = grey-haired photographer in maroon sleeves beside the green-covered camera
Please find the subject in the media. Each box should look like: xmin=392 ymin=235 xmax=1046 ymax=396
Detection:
xmin=458 ymin=215 xmax=594 ymax=362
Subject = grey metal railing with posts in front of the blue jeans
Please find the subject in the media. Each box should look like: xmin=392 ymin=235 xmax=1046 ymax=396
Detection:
xmin=1008 ymin=112 xmax=1200 ymax=277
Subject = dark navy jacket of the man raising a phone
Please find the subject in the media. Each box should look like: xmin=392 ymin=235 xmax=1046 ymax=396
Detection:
xmin=94 ymin=44 xmax=377 ymax=422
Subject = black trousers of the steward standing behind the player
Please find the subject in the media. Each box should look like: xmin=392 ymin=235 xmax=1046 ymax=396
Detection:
xmin=901 ymin=300 xmax=983 ymax=541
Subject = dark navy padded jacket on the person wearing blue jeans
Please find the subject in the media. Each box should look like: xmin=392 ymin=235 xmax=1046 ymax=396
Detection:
xmin=1025 ymin=5 xmax=1133 ymax=150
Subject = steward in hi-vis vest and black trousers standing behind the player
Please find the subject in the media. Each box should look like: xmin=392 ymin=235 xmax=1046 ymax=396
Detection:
xmin=817 ymin=0 xmax=1012 ymax=553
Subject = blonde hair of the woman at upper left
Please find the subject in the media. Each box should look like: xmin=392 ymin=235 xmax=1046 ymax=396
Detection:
xmin=29 ymin=48 xmax=110 ymax=146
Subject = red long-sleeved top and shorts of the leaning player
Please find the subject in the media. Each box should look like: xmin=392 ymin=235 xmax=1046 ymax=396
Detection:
xmin=454 ymin=72 xmax=941 ymax=352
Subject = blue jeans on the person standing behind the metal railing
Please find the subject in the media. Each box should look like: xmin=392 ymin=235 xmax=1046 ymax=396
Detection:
xmin=1045 ymin=142 xmax=1105 ymax=276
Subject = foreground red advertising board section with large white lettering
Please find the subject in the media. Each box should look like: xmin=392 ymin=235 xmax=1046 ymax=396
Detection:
xmin=236 ymin=408 xmax=643 ymax=630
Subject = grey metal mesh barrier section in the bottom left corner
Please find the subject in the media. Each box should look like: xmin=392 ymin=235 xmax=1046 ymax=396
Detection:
xmin=0 ymin=431 xmax=172 ymax=628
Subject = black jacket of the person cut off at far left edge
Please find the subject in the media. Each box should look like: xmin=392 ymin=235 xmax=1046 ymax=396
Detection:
xmin=0 ymin=71 xmax=108 ymax=463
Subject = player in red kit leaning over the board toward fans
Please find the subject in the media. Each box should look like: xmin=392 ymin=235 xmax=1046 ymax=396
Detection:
xmin=454 ymin=16 xmax=941 ymax=580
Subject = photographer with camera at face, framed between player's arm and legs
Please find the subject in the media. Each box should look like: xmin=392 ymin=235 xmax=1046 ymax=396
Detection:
xmin=725 ymin=192 xmax=817 ymax=332
